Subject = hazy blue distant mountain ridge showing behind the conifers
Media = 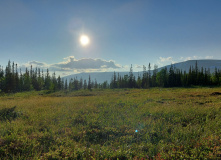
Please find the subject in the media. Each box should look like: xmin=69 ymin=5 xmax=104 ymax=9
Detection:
xmin=63 ymin=60 xmax=221 ymax=83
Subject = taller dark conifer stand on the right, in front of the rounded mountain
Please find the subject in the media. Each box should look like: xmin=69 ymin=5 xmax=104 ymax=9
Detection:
xmin=110 ymin=61 xmax=221 ymax=88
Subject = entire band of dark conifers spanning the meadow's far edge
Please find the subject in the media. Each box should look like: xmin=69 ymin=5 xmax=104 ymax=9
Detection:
xmin=0 ymin=61 xmax=221 ymax=93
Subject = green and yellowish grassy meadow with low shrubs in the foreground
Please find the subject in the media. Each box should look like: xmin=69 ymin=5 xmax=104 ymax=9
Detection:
xmin=0 ymin=88 xmax=221 ymax=159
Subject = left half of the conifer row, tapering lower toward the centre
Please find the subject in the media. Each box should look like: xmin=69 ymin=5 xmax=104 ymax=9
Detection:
xmin=0 ymin=60 xmax=109 ymax=93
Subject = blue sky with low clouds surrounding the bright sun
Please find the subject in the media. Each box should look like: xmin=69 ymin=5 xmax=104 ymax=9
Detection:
xmin=0 ymin=0 xmax=221 ymax=76
